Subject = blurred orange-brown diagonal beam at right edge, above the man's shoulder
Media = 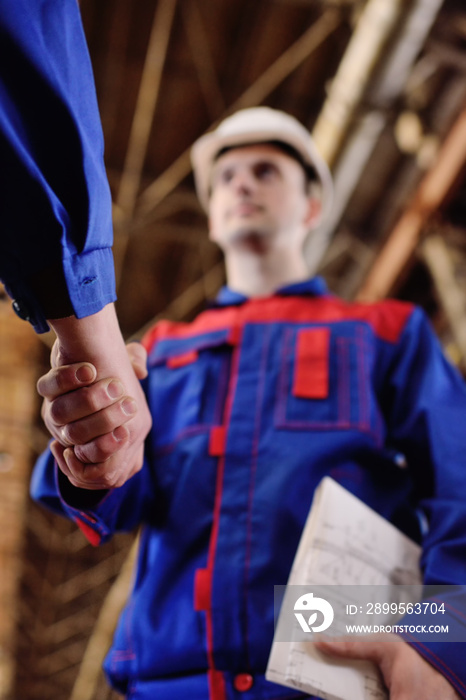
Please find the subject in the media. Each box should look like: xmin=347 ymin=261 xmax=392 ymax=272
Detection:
xmin=356 ymin=109 xmax=466 ymax=301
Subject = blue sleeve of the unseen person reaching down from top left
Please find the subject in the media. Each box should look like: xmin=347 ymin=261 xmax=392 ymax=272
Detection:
xmin=0 ymin=0 xmax=115 ymax=332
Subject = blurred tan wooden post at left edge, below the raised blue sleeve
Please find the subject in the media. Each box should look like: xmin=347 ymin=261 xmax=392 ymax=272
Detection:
xmin=0 ymin=301 xmax=41 ymax=700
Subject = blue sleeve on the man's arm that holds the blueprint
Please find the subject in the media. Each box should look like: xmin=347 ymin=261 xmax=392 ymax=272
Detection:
xmin=387 ymin=309 xmax=466 ymax=698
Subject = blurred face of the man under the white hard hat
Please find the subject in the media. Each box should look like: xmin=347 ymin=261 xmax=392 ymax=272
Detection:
xmin=209 ymin=144 xmax=319 ymax=252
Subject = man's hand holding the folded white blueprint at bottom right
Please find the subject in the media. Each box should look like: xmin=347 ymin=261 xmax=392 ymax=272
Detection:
xmin=314 ymin=634 xmax=461 ymax=700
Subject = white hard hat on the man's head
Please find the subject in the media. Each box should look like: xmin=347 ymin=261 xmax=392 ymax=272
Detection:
xmin=191 ymin=107 xmax=333 ymax=224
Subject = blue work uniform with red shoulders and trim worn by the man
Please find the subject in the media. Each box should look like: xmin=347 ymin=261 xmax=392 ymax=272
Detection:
xmin=32 ymin=278 xmax=466 ymax=700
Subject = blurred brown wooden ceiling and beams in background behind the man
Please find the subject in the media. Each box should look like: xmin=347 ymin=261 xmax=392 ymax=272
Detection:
xmin=0 ymin=0 xmax=466 ymax=700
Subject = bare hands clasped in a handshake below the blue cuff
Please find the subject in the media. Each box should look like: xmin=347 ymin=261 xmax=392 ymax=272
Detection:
xmin=37 ymin=343 xmax=151 ymax=490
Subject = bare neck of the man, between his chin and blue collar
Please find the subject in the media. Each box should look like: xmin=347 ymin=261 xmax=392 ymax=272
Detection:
xmin=225 ymin=245 xmax=309 ymax=297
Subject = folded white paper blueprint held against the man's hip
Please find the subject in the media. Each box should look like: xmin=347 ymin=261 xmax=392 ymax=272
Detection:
xmin=266 ymin=477 xmax=422 ymax=700
